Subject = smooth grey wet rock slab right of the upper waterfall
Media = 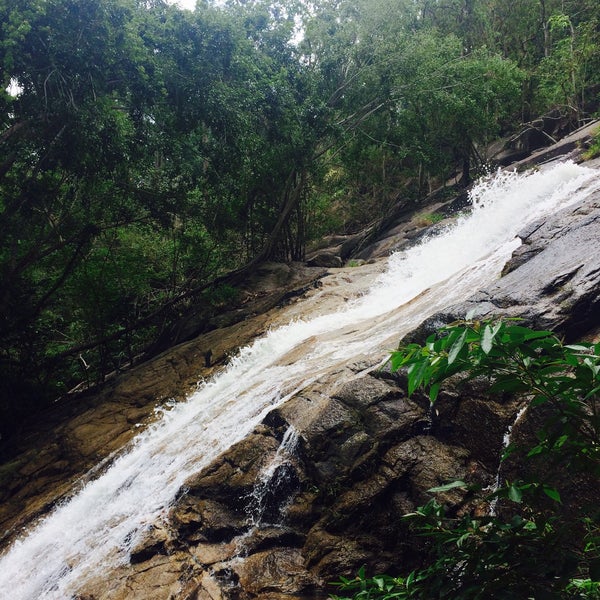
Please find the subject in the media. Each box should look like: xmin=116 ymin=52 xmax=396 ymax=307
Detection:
xmin=412 ymin=183 xmax=600 ymax=340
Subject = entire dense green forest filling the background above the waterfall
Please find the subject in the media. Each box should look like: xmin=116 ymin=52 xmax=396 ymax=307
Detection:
xmin=0 ymin=0 xmax=600 ymax=431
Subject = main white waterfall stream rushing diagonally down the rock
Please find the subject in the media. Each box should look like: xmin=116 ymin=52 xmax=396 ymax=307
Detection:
xmin=0 ymin=163 xmax=600 ymax=600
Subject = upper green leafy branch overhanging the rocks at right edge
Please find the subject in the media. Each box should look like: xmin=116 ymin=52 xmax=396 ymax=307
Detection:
xmin=391 ymin=321 xmax=600 ymax=473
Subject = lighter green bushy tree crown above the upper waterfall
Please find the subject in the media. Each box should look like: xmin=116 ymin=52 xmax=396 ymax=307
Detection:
xmin=306 ymin=3 xmax=522 ymax=214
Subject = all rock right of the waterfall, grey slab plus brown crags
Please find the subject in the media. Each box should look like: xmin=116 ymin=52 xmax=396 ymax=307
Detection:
xmin=86 ymin=175 xmax=600 ymax=598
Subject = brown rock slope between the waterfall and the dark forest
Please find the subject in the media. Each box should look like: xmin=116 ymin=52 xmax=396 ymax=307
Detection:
xmin=0 ymin=264 xmax=325 ymax=543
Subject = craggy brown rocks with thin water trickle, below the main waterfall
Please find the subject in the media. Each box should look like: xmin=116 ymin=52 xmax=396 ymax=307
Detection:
xmin=87 ymin=364 xmax=516 ymax=599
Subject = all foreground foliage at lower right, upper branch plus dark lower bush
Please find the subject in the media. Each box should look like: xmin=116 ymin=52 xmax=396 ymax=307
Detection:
xmin=334 ymin=320 xmax=600 ymax=600
